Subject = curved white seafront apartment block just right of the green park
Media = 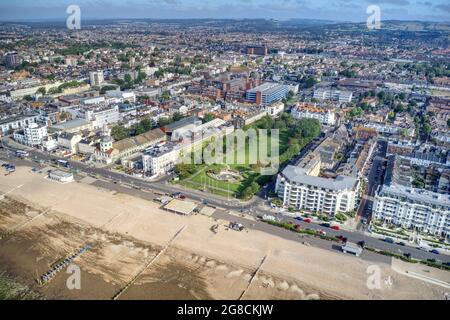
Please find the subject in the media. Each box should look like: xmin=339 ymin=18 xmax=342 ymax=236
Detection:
xmin=275 ymin=156 xmax=359 ymax=216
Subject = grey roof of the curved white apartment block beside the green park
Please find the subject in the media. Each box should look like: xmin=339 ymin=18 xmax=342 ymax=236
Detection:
xmin=281 ymin=166 xmax=358 ymax=191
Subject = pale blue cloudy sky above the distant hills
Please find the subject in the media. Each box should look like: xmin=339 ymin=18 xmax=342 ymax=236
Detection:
xmin=0 ymin=0 xmax=450 ymax=21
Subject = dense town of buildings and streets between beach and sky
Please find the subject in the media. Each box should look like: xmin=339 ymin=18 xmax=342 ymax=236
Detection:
xmin=0 ymin=20 xmax=450 ymax=296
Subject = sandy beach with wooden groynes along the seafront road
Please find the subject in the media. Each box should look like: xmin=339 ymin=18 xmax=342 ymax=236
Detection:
xmin=0 ymin=167 xmax=446 ymax=299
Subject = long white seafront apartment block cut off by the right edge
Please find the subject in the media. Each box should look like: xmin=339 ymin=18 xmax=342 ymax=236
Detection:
xmin=373 ymin=185 xmax=450 ymax=237
